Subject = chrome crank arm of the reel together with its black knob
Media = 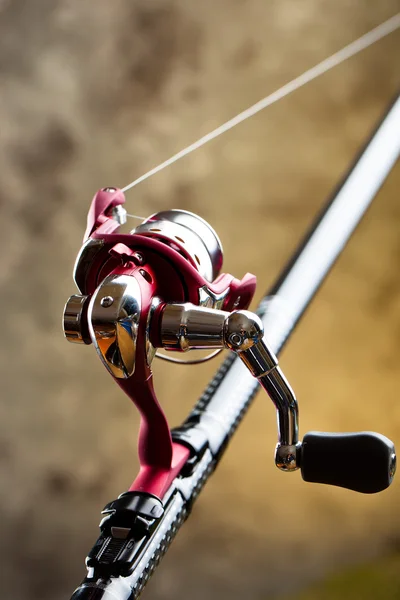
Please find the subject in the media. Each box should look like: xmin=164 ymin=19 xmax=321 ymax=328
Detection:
xmin=159 ymin=303 xmax=396 ymax=493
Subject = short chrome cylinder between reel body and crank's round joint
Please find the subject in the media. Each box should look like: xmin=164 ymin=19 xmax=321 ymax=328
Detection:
xmin=161 ymin=302 xmax=228 ymax=352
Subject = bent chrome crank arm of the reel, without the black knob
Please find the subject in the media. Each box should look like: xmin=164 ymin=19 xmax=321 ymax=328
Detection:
xmin=161 ymin=303 xmax=300 ymax=471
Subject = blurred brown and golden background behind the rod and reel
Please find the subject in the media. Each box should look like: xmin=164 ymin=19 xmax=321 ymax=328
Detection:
xmin=0 ymin=0 xmax=400 ymax=600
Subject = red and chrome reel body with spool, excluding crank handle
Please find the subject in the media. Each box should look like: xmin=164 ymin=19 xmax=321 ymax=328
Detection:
xmin=64 ymin=188 xmax=256 ymax=498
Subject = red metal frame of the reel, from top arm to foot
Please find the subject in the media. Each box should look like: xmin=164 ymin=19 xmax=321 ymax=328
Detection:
xmin=81 ymin=188 xmax=256 ymax=499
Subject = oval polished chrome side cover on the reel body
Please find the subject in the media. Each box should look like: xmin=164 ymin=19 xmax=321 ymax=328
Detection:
xmin=88 ymin=275 xmax=141 ymax=379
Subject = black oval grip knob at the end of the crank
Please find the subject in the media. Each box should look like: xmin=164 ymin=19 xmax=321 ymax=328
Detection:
xmin=301 ymin=431 xmax=396 ymax=494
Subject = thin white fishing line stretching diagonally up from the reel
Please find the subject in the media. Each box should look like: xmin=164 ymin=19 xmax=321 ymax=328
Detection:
xmin=122 ymin=13 xmax=400 ymax=192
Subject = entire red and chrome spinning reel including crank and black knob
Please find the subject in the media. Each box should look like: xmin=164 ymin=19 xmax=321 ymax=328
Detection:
xmin=64 ymin=188 xmax=396 ymax=499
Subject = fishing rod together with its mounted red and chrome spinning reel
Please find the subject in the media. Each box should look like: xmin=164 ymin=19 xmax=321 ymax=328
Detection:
xmin=64 ymin=90 xmax=400 ymax=600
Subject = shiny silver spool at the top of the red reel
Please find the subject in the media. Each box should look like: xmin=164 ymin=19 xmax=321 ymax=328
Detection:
xmin=132 ymin=209 xmax=223 ymax=281
